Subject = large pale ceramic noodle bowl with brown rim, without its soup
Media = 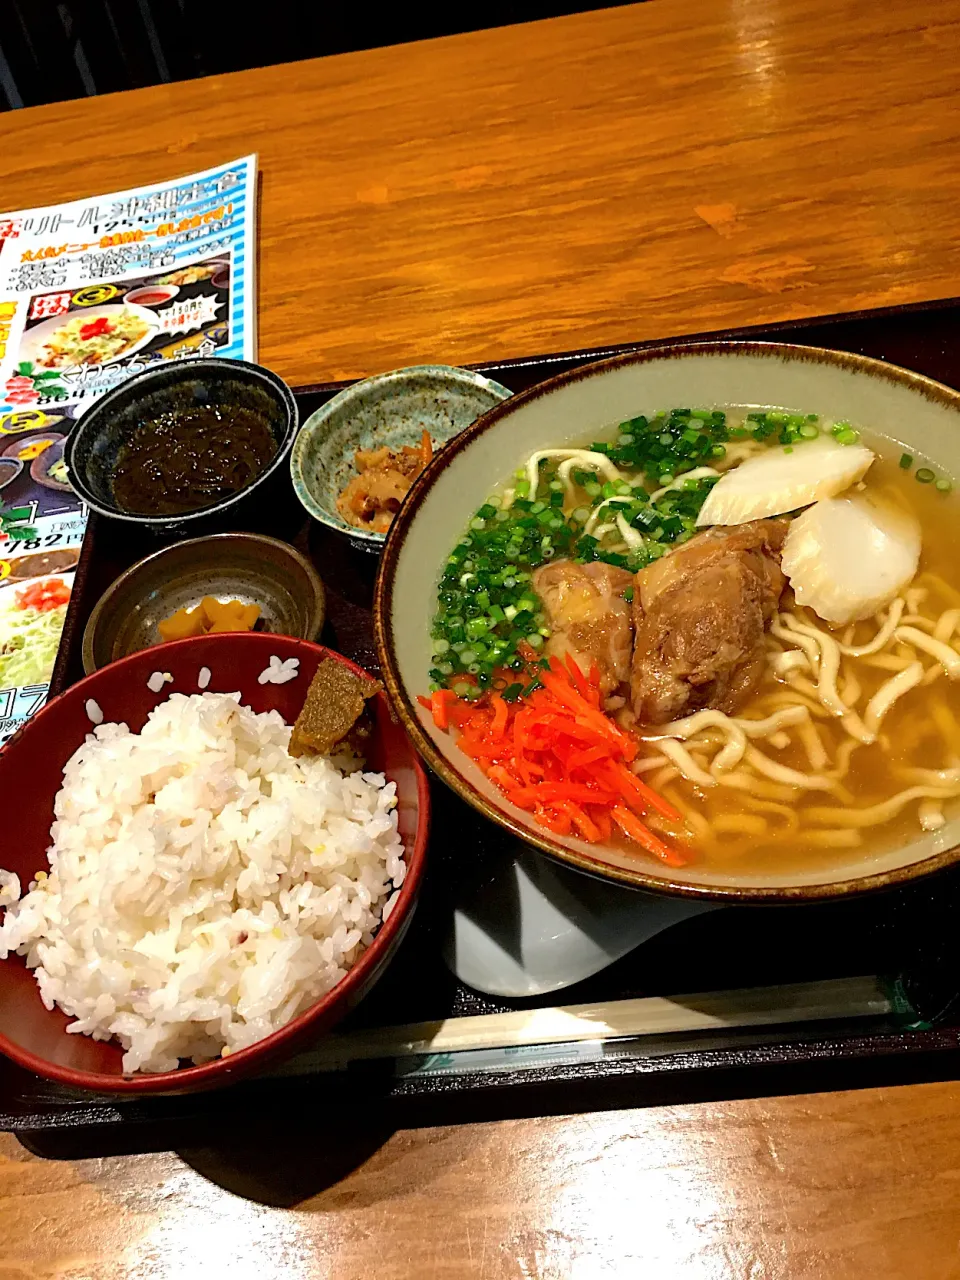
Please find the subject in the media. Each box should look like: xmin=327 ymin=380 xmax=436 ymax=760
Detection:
xmin=375 ymin=343 xmax=960 ymax=902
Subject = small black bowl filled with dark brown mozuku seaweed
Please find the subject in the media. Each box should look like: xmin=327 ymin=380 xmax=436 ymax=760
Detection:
xmin=64 ymin=358 xmax=298 ymax=532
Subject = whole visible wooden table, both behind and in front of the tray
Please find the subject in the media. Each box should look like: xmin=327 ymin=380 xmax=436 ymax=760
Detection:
xmin=0 ymin=0 xmax=960 ymax=1280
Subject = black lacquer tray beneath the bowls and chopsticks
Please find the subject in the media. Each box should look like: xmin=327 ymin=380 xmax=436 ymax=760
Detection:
xmin=11 ymin=300 xmax=960 ymax=1156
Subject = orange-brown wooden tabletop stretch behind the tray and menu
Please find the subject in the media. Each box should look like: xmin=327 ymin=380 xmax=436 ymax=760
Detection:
xmin=1 ymin=0 xmax=960 ymax=385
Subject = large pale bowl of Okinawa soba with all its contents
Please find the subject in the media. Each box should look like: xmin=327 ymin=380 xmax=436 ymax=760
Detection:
xmin=375 ymin=343 xmax=960 ymax=902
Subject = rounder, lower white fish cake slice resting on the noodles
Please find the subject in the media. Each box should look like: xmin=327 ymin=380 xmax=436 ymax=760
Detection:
xmin=781 ymin=493 xmax=920 ymax=625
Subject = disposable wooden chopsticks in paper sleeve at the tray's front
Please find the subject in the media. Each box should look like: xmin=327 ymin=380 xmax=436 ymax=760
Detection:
xmin=270 ymin=977 xmax=895 ymax=1075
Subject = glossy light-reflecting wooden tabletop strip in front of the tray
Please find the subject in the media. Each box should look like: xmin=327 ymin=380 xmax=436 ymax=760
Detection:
xmin=0 ymin=1084 xmax=960 ymax=1280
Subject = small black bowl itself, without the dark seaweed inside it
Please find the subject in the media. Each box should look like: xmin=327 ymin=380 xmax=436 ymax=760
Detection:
xmin=64 ymin=358 xmax=298 ymax=534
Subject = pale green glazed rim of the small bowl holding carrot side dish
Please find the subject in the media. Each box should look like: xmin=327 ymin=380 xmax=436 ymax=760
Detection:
xmin=291 ymin=365 xmax=513 ymax=550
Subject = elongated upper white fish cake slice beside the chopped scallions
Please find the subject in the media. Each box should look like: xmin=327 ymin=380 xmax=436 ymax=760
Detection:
xmin=696 ymin=435 xmax=874 ymax=525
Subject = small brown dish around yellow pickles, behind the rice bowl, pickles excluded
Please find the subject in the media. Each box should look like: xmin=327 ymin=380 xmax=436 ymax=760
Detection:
xmin=83 ymin=534 xmax=325 ymax=675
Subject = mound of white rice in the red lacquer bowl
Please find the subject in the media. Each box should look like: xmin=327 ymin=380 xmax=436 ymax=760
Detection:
xmin=0 ymin=694 xmax=406 ymax=1071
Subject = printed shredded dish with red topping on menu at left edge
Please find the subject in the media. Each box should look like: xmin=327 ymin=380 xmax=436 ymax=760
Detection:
xmin=0 ymin=577 xmax=70 ymax=689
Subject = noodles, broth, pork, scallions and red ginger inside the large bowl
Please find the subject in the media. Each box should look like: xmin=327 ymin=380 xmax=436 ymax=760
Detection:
xmin=421 ymin=408 xmax=960 ymax=873
